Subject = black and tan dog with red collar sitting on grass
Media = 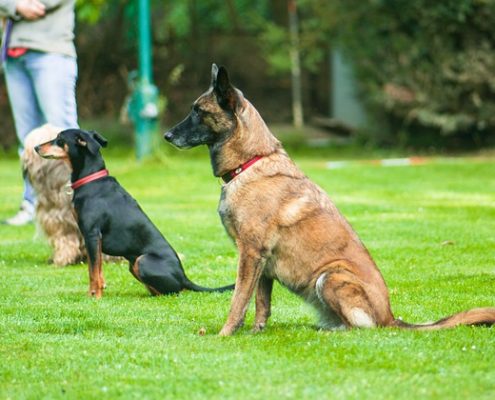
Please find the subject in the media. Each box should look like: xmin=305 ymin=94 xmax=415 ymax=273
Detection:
xmin=35 ymin=129 xmax=233 ymax=298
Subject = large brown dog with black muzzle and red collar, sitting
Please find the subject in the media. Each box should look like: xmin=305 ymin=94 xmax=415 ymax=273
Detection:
xmin=164 ymin=64 xmax=495 ymax=336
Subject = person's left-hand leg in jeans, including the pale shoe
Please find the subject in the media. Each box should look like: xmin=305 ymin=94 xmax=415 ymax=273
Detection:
xmin=5 ymin=56 xmax=43 ymax=225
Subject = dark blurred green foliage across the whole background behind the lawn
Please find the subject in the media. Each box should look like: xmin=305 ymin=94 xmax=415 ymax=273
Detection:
xmin=0 ymin=0 xmax=495 ymax=146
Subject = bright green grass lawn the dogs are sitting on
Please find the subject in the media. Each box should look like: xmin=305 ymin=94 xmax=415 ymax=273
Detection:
xmin=0 ymin=142 xmax=495 ymax=399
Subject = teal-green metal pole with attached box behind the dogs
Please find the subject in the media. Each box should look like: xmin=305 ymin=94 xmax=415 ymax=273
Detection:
xmin=134 ymin=0 xmax=158 ymax=160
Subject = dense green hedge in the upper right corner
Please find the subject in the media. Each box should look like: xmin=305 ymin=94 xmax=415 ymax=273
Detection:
xmin=334 ymin=0 xmax=495 ymax=142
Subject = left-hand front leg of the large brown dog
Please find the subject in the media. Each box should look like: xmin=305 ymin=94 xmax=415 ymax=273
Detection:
xmin=220 ymin=252 xmax=263 ymax=336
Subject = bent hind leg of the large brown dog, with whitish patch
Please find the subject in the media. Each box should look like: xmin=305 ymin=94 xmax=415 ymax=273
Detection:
xmin=316 ymin=266 xmax=378 ymax=328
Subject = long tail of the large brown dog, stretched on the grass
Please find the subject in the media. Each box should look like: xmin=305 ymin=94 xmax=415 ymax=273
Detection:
xmin=390 ymin=308 xmax=495 ymax=331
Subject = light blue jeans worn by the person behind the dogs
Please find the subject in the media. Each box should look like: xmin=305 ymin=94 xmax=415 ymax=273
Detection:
xmin=4 ymin=51 xmax=78 ymax=204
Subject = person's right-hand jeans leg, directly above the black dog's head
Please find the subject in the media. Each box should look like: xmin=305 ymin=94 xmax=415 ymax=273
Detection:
xmin=27 ymin=52 xmax=78 ymax=129
